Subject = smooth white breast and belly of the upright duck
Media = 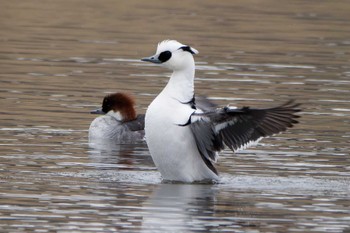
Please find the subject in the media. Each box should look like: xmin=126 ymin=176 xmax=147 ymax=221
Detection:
xmin=145 ymin=93 xmax=218 ymax=182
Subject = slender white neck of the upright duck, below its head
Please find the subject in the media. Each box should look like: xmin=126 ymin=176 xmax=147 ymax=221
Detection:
xmin=164 ymin=66 xmax=195 ymax=103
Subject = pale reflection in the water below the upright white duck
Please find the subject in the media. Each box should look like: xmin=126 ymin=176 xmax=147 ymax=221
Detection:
xmin=142 ymin=183 xmax=216 ymax=232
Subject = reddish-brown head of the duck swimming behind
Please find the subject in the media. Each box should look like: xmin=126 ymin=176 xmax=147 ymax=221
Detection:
xmin=102 ymin=92 xmax=136 ymax=121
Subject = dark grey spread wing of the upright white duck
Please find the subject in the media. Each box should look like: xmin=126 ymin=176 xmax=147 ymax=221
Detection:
xmin=190 ymin=101 xmax=300 ymax=162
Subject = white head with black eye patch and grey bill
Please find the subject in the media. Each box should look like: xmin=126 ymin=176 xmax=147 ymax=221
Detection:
xmin=141 ymin=40 xmax=198 ymax=70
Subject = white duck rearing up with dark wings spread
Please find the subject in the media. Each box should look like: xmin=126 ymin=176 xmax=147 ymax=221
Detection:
xmin=142 ymin=40 xmax=299 ymax=182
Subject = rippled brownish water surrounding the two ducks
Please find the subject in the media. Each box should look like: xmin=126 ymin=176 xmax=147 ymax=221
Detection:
xmin=0 ymin=0 xmax=350 ymax=232
